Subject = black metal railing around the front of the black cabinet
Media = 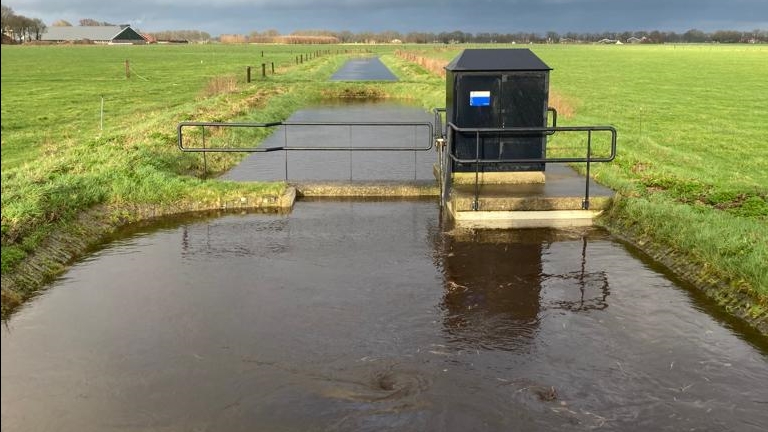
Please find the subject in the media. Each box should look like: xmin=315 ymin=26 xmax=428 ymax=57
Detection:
xmin=436 ymin=121 xmax=616 ymax=210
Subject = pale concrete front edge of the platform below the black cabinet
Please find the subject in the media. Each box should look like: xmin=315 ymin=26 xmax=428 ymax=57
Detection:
xmin=448 ymin=203 xmax=602 ymax=229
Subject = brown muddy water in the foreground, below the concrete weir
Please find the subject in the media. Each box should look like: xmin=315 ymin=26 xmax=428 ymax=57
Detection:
xmin=2 ymin=201 xmax=768 ymax=431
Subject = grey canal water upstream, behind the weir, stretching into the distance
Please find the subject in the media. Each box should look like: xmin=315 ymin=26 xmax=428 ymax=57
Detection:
xmin=221 ymin=57 xmax=426 ymax=183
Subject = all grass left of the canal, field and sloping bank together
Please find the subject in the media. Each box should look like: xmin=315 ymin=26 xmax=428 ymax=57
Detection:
xmin=2 ymin=45 xmax=364 ymax=316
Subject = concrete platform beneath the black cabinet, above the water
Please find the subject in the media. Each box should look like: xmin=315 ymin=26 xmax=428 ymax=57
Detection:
xmin=447 ymin=164 xmax=614 ymax=228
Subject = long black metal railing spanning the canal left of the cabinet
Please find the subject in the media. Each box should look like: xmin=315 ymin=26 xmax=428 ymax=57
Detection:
xmin=176 ymin=121 xmax=434 ymax=181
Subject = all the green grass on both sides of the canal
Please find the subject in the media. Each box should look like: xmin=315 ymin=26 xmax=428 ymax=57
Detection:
xmin=2 ymin=45 xmax=768 ymax=322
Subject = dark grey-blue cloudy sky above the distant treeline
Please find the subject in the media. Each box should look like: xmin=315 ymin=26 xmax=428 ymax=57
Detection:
xmin=10 ymin=0 xmax=768 ymax=36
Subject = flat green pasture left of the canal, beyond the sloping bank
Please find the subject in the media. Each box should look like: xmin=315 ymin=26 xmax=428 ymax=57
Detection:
xmin=2 ymin=45 xmax=338 ymax=169
